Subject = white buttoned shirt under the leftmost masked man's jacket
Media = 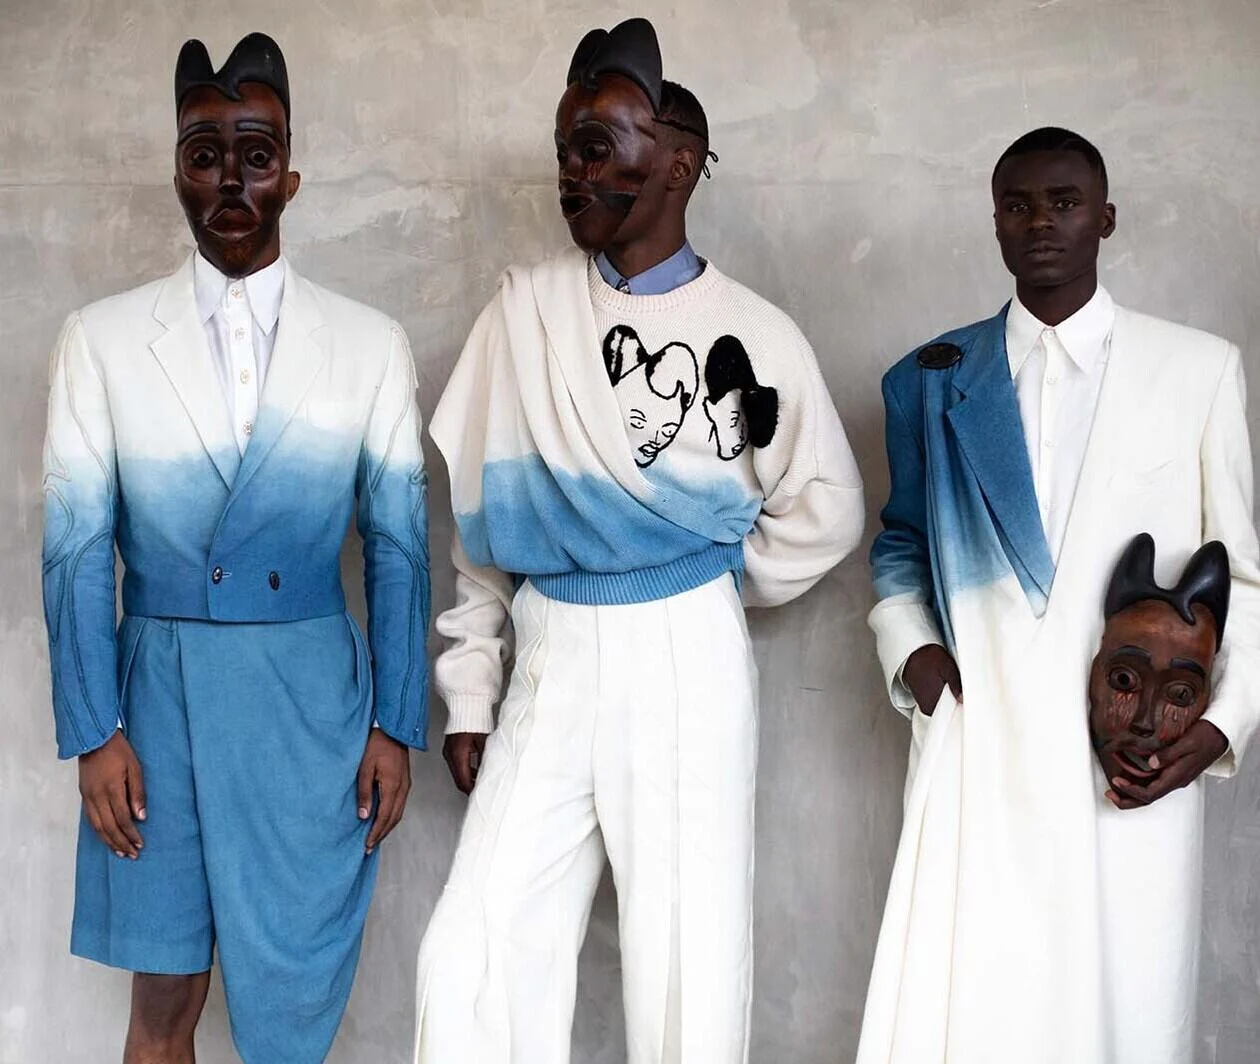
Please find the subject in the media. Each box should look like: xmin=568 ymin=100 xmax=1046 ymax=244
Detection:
xmin=193 ymin=251 xmax=285 ymax=454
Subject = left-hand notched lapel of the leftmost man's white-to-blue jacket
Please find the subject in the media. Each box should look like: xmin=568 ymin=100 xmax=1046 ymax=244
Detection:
xmin=149 ymin=255 xmax=241 ymax=488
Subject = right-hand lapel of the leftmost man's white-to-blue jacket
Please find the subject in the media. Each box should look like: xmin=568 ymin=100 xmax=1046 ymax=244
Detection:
xmin=233 ymin=266 xmax=330 ymax=493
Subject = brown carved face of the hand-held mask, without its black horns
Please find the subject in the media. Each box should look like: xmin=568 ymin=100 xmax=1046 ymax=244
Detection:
xmin=1090 ymin=599 xmax=1216 ymax=783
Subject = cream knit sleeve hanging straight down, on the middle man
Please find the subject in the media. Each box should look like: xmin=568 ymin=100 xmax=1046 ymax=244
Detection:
xmin=433 ymin=529 xmax=515 ymax=735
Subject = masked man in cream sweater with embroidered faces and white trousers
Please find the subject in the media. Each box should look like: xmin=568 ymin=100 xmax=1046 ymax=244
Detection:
xmin=416 ymin=19 xmax=863 ymax=1064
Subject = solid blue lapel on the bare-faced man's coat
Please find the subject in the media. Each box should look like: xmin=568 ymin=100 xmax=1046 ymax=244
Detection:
xmin=946 ymin=308 xmax=1055 ymax=598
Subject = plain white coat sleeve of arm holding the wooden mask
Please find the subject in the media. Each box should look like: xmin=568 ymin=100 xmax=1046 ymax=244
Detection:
xmin=1200 ymin=345 xmax=1260 ymax=777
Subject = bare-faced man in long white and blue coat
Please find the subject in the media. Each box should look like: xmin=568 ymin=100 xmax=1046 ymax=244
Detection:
xmin=858 ymin=127 xmax=1260 ymax=1064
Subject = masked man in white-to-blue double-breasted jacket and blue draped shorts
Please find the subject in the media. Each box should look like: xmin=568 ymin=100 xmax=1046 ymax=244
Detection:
xmin=44 ymin=34 xmax=428 ymax=1064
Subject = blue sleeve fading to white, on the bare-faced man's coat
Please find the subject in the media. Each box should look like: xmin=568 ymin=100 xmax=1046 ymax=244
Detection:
xmin=869 ymin=376 xmax=945 ymax=714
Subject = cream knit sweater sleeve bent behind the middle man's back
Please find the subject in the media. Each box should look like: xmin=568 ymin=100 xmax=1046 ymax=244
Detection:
xmin=743 ymin=334 xmax=866 ymax=606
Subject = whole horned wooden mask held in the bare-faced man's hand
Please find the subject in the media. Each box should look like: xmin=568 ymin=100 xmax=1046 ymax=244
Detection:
xmin=1089 ymin=533 xmax=1230 ymax=783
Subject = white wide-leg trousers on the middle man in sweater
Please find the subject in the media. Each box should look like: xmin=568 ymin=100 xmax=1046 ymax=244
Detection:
xmin=415 ymin=575 xmax=757 ymax=1064
